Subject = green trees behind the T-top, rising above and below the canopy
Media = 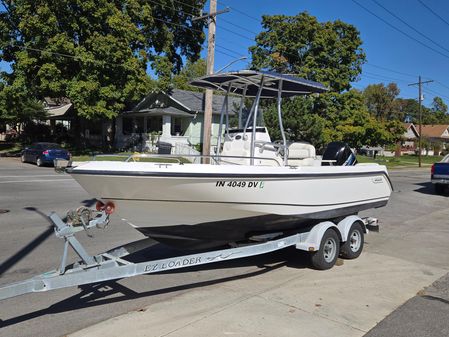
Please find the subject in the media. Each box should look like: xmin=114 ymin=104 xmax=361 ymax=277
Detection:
xmin=250 ymin=13 xmax=392 ymax=148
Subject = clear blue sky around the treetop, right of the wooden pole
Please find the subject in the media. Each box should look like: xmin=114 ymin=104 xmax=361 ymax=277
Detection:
xmin=203 ymin=0 xmax=449 ymax=106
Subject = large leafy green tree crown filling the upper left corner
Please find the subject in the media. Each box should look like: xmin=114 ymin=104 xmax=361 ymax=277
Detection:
xmin=0 ymin=0 xmax=205 ymax=119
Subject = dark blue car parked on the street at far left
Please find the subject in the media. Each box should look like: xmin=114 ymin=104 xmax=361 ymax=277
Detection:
xmin=22 ymin=143 xmax=70 ymax=166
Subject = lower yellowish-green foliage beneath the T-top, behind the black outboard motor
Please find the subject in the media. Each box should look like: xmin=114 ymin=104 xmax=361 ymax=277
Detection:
xmin=265 ymin=90 xmax=393 ymax=148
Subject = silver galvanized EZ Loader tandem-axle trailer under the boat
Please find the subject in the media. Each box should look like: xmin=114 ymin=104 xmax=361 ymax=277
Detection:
xmin=0 ymin=207 xmax=378 ymax=300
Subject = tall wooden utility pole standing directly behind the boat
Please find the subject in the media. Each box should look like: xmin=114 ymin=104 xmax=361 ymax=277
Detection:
xmin=203 ymin=0 xmax=217 ymax=163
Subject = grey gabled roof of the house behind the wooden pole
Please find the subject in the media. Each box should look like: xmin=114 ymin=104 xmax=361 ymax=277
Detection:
xmin=125 ymin=89 xmax=240 ymax=116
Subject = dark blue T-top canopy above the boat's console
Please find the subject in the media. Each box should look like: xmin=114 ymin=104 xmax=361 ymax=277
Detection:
xmin=190 ymin=70 xmax=328 ymax=98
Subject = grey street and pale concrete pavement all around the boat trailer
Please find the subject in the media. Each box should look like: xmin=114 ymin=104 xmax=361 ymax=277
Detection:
xmin=0 ymin=158 xmax=449 ymax=336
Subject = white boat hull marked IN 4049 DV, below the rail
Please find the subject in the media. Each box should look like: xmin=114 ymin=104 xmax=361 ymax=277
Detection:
xmin=70 ymin=162 xmax=392 ymax=247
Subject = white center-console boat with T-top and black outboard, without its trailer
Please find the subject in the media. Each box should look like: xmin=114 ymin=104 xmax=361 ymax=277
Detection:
xmin=66 ymin=70 xmax=392 ymax=248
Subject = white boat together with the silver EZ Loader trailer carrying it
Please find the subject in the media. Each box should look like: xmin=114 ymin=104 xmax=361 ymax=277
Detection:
xmin=0 ymin=71 xmax=392 ymax=300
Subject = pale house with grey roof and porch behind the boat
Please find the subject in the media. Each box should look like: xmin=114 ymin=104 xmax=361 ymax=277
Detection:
xmin=115 ymin=89 xmax=240 ymax=148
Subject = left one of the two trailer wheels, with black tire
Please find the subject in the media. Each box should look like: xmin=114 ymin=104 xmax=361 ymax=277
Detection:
xmin=310 ymin=228 xmax=340 ymax=270
